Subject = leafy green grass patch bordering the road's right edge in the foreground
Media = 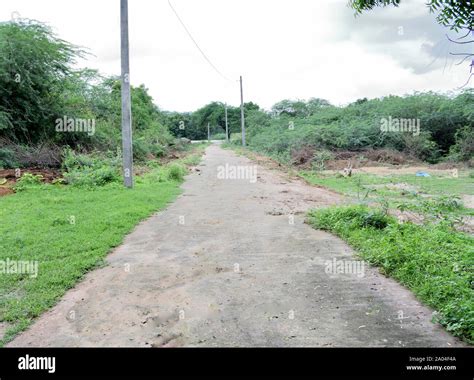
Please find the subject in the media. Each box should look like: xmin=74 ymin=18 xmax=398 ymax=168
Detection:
xmin=308 ymin=205 xmax=474 ymax=344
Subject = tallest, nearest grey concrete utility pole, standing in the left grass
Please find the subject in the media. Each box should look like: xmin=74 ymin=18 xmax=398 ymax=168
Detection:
xmin=120 ymin=0 xmax=133 ymax=188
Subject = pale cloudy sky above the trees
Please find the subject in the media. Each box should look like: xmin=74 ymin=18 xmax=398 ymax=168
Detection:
xmin=0 ymin=0 xmax=469 ymax=111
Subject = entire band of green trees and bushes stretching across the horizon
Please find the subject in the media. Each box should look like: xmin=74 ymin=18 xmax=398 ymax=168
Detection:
xmin=0 ymin=19 xmax=474 ymax=167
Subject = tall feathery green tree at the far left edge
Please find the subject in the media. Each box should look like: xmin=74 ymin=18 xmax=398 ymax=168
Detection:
xmin=0 ymin=19 xmax=84 ymax=142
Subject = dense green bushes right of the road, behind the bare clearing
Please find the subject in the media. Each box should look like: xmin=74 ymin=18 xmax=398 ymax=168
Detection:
xmin=223 ymin=94 xmax=474 ymax=164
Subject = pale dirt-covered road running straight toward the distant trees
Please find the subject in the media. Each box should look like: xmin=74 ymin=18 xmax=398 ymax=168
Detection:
xmin=9 ymin=145 xmax=460 ymax=347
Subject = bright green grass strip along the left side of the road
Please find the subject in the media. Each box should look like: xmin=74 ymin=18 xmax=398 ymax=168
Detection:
xmin=0 ymin=146 xmax=204 ymax=345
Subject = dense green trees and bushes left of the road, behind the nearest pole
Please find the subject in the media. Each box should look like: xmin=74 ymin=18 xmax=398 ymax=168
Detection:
xmin=0 ymin=20 xmax=174 ymax=168
